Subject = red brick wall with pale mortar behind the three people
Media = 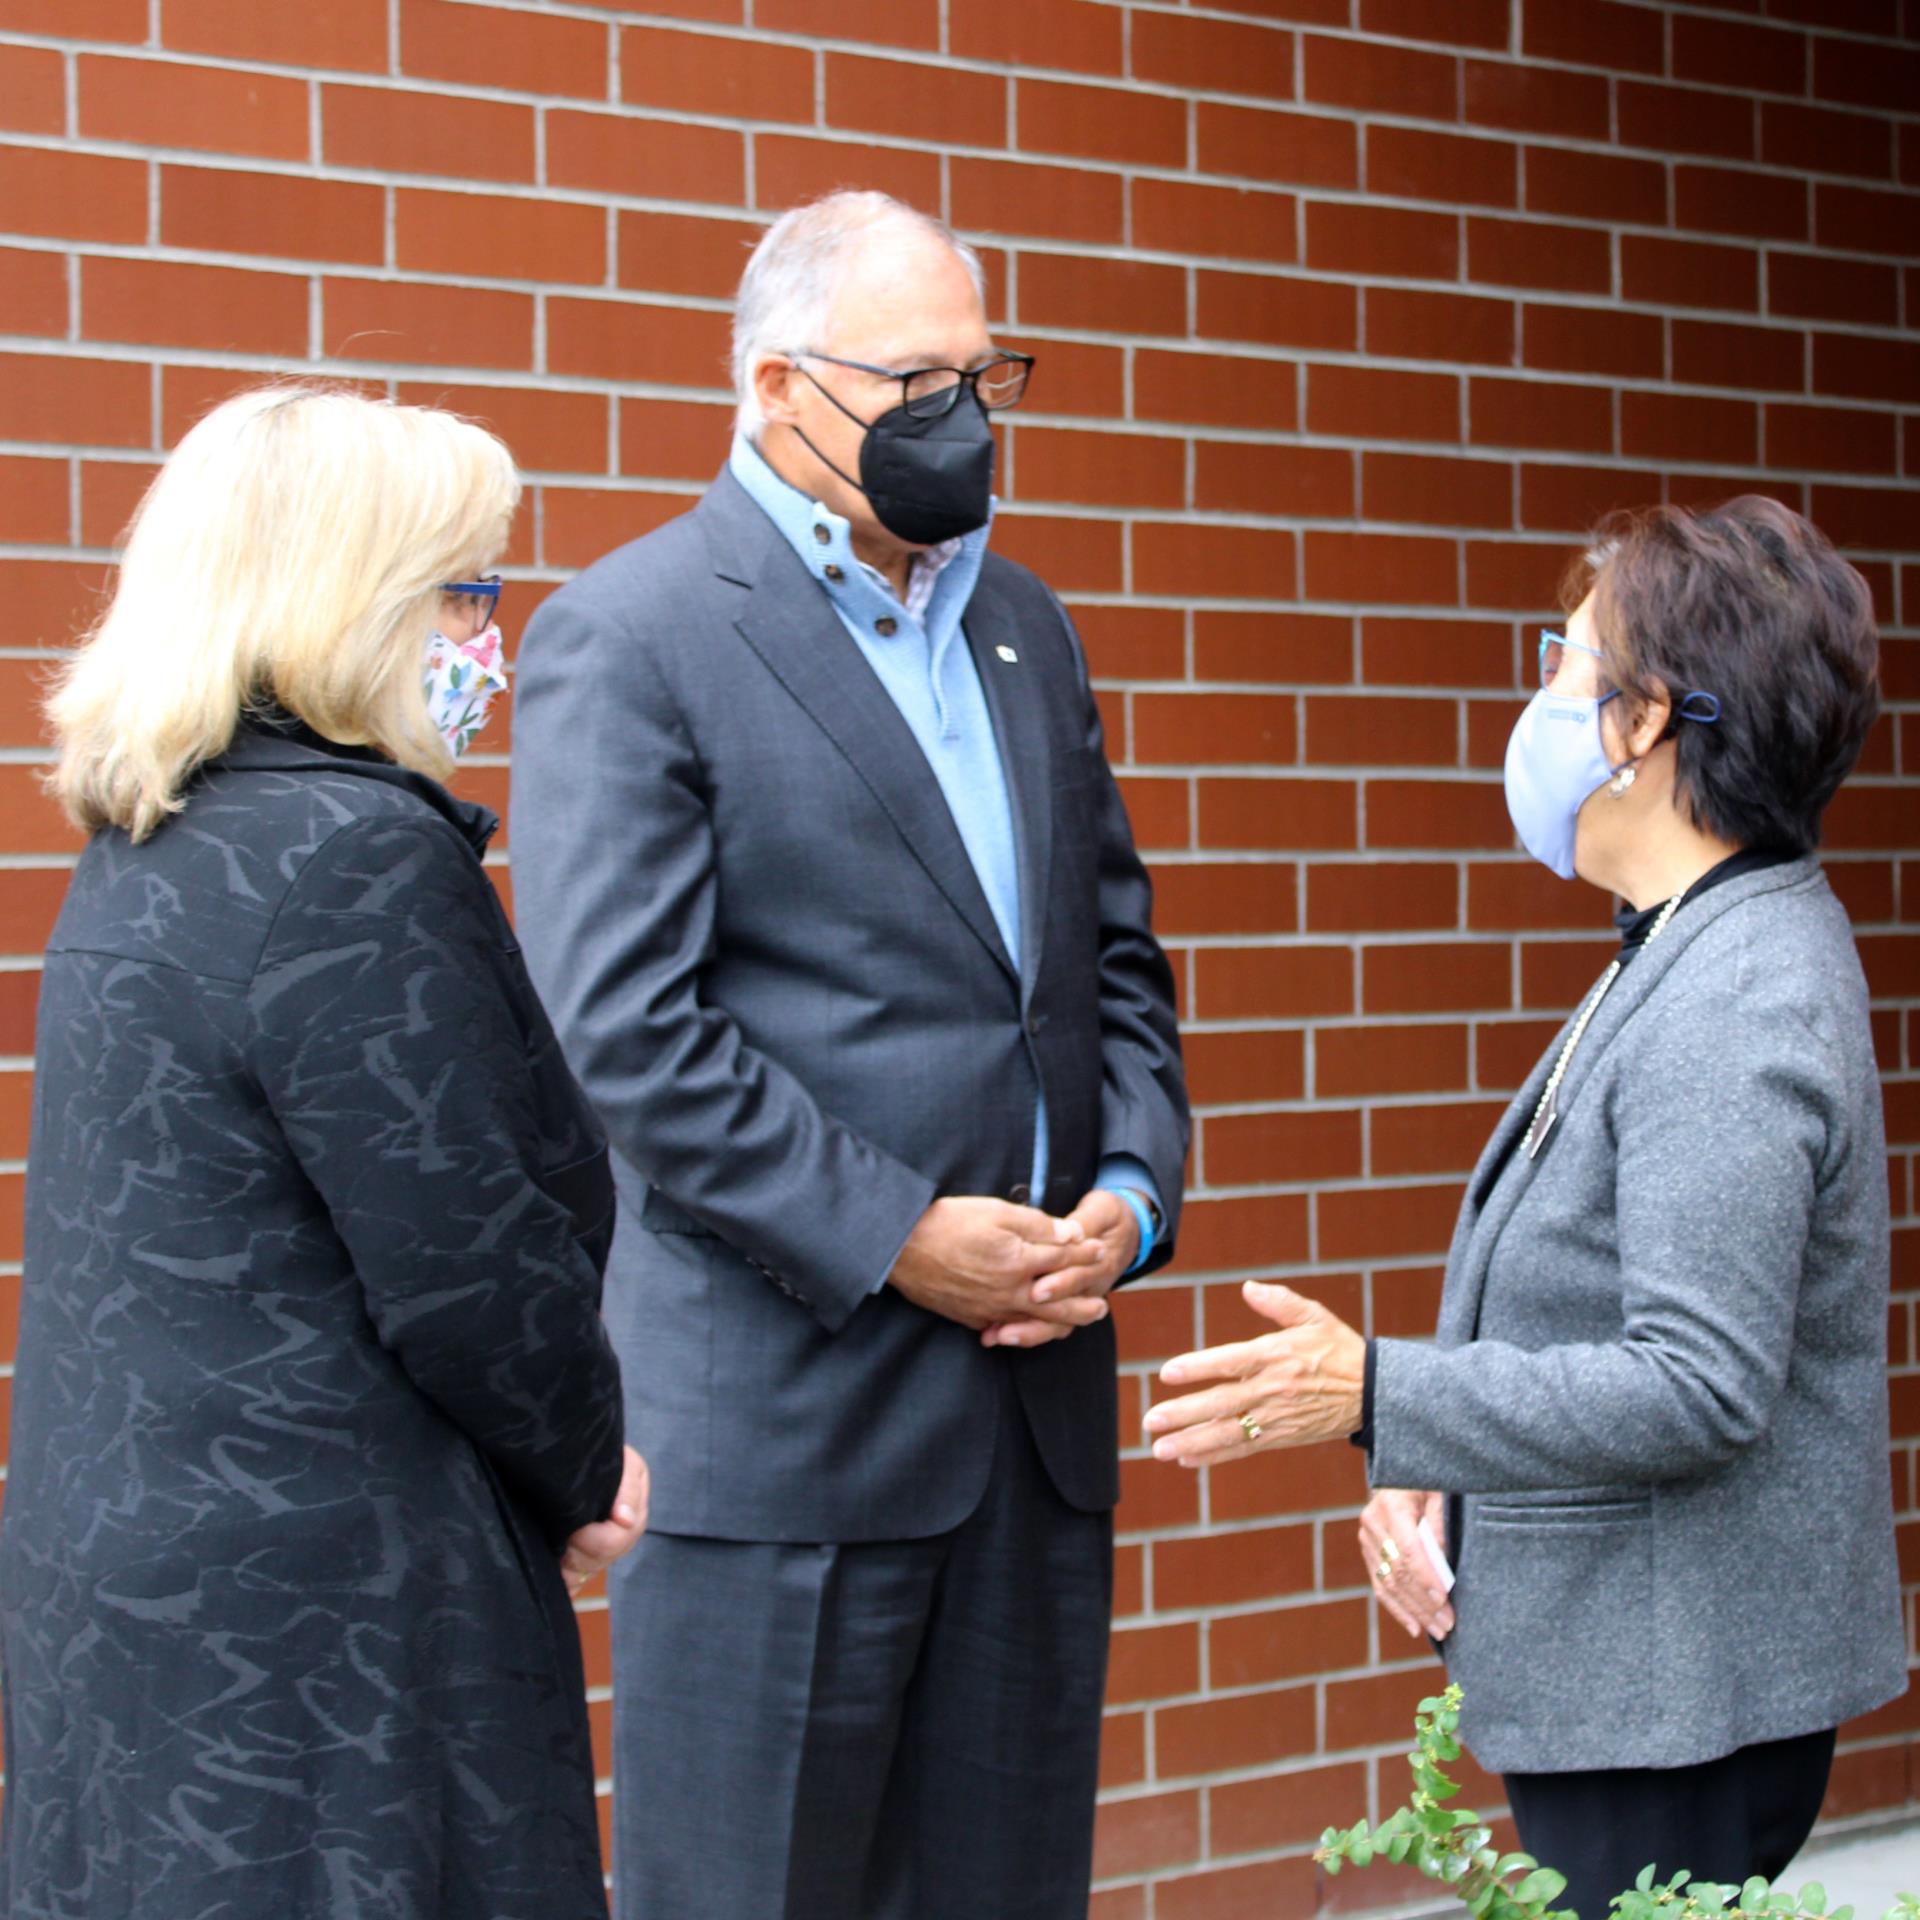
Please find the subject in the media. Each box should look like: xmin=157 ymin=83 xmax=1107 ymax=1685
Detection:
xmin=0 ymin=0 xmax=1920 ymax=1920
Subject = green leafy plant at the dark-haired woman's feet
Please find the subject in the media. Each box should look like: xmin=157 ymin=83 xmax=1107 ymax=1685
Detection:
xmin=1313 ymin=1686 xmax=1920 ymax=1920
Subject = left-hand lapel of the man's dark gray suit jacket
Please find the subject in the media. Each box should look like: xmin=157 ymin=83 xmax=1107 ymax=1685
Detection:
xmin=703 ymin=474 xmax=1018 ymax=979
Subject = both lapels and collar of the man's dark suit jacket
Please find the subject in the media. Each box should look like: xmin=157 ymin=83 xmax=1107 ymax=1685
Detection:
xmin=695 ymin=470 xmax=1052 ymax=995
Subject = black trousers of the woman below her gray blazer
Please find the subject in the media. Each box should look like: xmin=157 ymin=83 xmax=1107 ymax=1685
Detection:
xmin=1505 ymin=1728 xmax=1834 ymax=1920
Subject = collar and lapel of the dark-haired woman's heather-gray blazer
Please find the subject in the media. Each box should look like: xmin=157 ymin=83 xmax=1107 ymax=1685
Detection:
xmin=1438 ymin=856 xmax=1820 ymax=1344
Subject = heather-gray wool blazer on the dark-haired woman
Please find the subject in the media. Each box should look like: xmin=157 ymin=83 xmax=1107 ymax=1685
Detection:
xmin=1371 ymin=860 xmax=1907 ymax=1772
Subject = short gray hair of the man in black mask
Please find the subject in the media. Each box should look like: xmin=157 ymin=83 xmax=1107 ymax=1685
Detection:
xmin=733 ymin=190 xmax=987 ymax=434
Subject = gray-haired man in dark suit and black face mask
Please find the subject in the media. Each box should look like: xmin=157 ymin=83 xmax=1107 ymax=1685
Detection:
xmin=513 ymin=194 xmax=1188 ymax=1920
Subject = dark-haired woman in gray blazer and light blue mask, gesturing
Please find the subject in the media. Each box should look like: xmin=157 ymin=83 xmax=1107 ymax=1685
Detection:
xmin=1148 ymin=499 xmax=1907 ymax=1916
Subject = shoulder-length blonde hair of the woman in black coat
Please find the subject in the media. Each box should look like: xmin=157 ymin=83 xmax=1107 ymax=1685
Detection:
xmin=48 ymin=384 xmax=520 ymax=841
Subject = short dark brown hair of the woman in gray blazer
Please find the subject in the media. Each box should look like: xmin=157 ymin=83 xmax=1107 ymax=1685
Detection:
xmin=1565 ymin=493 xmax=1880 ymax=852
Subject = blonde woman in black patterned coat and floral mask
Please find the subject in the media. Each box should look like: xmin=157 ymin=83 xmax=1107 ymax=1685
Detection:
xmin=0 ymin=388 xmax=645 ymax=1920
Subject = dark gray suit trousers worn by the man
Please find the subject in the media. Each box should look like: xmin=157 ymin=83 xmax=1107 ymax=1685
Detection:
xmin=612 ymin=1356 xmax=1114 ymax=1920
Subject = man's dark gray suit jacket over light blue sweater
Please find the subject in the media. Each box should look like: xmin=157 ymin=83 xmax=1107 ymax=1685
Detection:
xmin=513 ymin=474 xmax=1187 ymax=1542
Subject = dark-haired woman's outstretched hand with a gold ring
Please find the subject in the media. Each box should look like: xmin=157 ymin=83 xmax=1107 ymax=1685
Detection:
xmin=1146 ymin=1281 xmax=1367 ymax=1467
